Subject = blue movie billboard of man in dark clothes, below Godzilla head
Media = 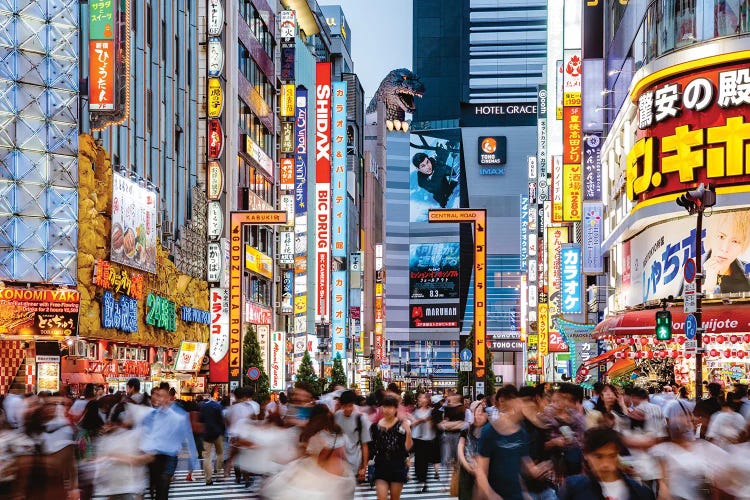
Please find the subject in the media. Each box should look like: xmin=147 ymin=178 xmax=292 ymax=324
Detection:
xmin=409 ymin=134 xmax=461 ymax=222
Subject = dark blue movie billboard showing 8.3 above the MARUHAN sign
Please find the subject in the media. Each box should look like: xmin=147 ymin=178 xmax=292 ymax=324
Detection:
xmin=409 ymin=242 xmax=460 ymax=299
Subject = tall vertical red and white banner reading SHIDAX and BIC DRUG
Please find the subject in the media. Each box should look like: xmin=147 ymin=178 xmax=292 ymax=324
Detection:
xmin=315 ymin=62 xmax=331 ymax=322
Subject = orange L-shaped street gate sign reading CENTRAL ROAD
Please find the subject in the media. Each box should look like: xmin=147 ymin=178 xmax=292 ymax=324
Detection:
xmin=427 ymin=209 xmax=487 ymax=380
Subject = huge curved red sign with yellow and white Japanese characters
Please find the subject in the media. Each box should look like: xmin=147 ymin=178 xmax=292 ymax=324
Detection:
xmin=626 ymin=58 xmax=750 ymax=203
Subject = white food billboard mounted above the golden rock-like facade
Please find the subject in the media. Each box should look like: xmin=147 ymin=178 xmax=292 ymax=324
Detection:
xmin=111 ymin=172 xmax=157 ymax=273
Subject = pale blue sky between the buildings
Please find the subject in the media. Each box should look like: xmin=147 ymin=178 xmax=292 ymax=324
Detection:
xmin=318 ymin=0 xmax=412 ymax=101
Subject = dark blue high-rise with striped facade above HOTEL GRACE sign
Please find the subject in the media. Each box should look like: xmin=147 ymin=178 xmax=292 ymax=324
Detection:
xmin=414 ymin=0 xmax=547 ymax=122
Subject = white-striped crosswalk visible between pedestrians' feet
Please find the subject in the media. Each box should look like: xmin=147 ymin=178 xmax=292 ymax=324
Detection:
xmin=100 ymin=469 xmax=452 ymax=500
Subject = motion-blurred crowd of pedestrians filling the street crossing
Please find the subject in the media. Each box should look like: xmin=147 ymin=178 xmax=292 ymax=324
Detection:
xmin=0 ymin=379 xmax=750 ymax=500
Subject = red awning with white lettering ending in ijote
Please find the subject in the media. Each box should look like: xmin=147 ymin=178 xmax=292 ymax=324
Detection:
xmin=594 ymin=304 xmax=750 ymax=339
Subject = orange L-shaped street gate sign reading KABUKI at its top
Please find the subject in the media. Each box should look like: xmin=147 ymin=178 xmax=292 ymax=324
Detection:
xmin=229 ymin=211 xmax=286 ymax=386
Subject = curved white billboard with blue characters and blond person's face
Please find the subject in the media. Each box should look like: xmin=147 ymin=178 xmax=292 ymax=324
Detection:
xmin=626 ymin=208 xmax=750 ymax=306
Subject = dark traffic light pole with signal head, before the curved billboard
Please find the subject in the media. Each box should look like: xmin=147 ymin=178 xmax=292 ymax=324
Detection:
xmin=676 ymin=183 xmax=716 ymax=401
